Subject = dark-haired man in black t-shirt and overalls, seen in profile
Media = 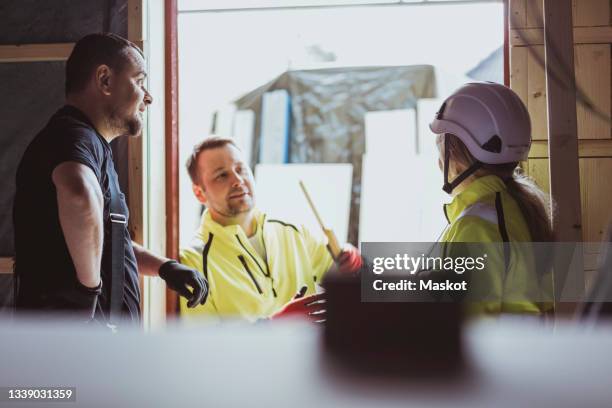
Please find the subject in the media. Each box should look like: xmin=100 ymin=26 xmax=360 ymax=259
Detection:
xmin=13 ymin=34 xmax=208 ymax=324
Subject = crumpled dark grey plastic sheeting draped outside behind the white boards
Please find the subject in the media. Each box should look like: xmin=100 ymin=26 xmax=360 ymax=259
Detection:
xmin=235 ymin=65 xmax=436 ymax=243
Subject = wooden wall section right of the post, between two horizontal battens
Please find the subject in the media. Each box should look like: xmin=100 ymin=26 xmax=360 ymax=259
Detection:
xmin=574 ymin=44 xmax=611 ymax=139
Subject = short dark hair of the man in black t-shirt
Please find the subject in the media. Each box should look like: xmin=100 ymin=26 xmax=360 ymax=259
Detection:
xmin=66 ymin=33 xmax=142 ymax=95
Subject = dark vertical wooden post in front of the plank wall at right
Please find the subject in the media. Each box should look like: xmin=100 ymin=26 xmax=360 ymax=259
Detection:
xmin=544 ymin=0 xmax=584 ymax=314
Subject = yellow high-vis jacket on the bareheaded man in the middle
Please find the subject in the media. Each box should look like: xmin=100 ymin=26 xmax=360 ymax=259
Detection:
xmin=180 ymin=211 xmax=333 ymax=321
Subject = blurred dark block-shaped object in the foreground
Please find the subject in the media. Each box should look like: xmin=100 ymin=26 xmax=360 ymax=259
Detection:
xmin=323 ymin=268 xmax=464 ymax=376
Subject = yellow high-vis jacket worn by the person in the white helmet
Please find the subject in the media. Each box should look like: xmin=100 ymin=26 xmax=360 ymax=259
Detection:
xmin=441 ymin=175 xmax=552 ymax=314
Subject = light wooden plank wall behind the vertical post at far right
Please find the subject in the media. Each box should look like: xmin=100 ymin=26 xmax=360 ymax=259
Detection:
xmin=509 ymin=0 xmax=612 ymax=306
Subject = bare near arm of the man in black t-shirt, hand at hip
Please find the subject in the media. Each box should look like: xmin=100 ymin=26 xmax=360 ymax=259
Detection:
xmin=51 ymin=162 xmax=104 ymax=288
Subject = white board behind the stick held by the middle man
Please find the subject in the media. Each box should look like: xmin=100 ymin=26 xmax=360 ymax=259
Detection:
xmin=255 ymin=164 xmax=353 ymax=242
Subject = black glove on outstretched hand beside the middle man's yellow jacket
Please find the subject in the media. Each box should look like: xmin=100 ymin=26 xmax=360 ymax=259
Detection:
xmin=159 ymin=261 xmax=208 ymax=307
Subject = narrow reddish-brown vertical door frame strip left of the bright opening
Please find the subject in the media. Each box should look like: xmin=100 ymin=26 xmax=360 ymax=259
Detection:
xmin=164 ymin=0 xmax=179 ymax=318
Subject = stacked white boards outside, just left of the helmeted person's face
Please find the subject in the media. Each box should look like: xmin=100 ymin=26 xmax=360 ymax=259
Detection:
xmin=359 ymin=109 xmax=445 ymax=242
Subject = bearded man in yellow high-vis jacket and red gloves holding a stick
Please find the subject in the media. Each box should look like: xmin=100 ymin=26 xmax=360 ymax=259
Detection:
xmin=181 ymin=137 xmax=361 ymax=321
